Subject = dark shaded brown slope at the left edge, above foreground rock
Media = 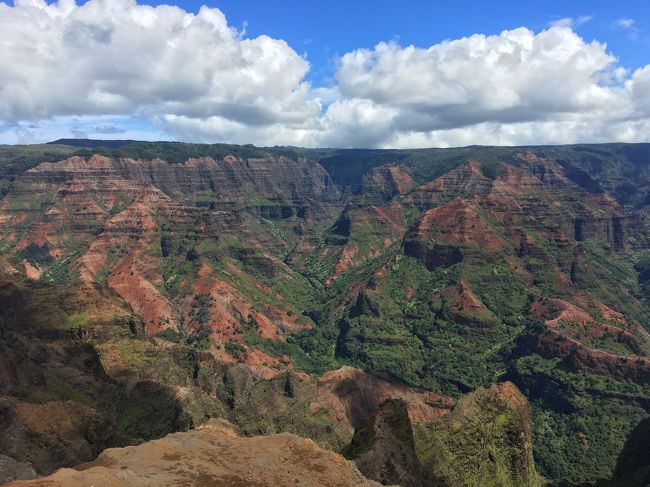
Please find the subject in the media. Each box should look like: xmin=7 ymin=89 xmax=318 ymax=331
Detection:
xmin=0 ymin=262 xmax=190 ymax=474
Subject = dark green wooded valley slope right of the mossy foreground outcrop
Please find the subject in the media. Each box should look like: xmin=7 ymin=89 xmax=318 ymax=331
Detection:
xmin=515 ymin=355 xmax=650 ymax=482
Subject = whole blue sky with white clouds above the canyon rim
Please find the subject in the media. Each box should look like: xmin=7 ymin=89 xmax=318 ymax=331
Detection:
xmin=0 ymin=0 xmax=650 ymax=148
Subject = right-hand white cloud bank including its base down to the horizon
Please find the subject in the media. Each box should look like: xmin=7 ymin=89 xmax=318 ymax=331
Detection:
xmin=330 ymin=26 xmax=648 ymax=147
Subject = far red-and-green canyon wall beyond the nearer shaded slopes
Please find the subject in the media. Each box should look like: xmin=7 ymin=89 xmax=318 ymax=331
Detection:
xmin=0 ymin=142 xmax=650 ymax=482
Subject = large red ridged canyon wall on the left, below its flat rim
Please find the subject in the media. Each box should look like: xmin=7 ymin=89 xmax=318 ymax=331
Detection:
xmin=0 ymin=155 xmax=340 ymax=366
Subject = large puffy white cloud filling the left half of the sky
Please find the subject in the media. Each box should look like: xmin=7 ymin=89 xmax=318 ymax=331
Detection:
xmin=0 ymin=0 xmax=320 ymax=133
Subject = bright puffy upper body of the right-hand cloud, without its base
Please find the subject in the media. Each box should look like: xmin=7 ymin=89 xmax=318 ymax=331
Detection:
xmin=338 ymin=28 xmax=615 ymax=124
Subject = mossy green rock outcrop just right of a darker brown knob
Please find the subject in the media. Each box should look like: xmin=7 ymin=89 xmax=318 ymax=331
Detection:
xmin=414 ymin=382 xmax=541 ymax=487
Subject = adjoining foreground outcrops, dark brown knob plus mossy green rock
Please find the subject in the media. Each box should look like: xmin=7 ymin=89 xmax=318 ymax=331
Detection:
xmin=344 ymin=382 xmax=541 ymax=487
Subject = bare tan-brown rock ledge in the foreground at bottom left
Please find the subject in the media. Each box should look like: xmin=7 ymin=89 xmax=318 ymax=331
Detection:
xmin=9 ymin=421 xmax=379 ymax=487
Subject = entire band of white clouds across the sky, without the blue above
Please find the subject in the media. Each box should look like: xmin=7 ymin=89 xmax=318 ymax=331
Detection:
xmin=0 ymin=0 xmax=650 ymax=147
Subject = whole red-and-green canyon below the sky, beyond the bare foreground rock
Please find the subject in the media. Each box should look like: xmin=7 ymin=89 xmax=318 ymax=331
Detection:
xmin=0 ymin=141 xmax=650 ymax=486
